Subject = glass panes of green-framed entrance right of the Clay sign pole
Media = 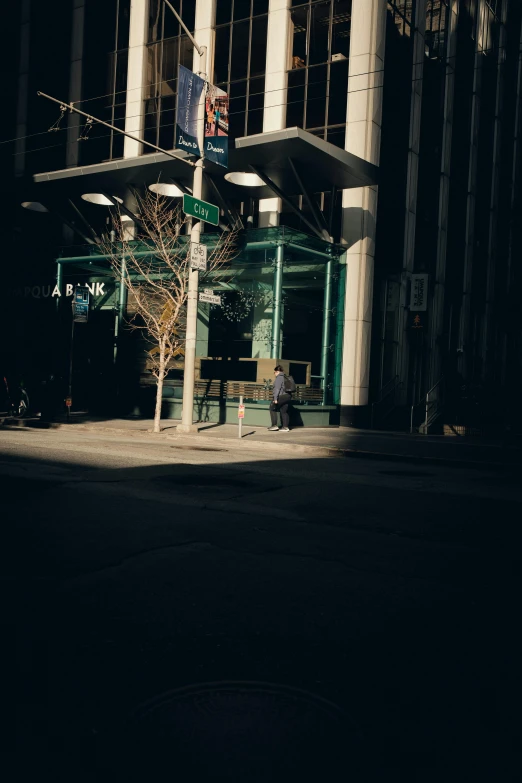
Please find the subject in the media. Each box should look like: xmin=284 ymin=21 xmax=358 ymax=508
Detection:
xmin=197 ymin=227 xmax=341 ymax=406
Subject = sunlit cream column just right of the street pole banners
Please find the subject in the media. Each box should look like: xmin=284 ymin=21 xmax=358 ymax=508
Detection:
xmin=259 ymin=0 xmax=292 ymax=228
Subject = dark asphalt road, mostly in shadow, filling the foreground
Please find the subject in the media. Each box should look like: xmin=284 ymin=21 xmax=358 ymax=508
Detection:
xmin=5 ymin=430 xmax=521 ymax=783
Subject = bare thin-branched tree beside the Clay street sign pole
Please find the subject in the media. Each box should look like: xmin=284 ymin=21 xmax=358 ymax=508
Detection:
xmin=105 ymin=191 xmax=237 ymax=432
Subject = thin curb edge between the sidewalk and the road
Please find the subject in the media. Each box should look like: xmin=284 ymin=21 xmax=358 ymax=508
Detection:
xmin=0 ymin=419 xmax=517 ymax=471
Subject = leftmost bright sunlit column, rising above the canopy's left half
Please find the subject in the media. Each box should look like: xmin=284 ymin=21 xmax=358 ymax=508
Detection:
xmin=123 ymin=0 xmax=149 ymax=158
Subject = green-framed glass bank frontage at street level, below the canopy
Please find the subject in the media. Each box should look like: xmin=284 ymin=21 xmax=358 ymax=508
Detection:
xmin=54 ymin=226 xmax=344 ymax=426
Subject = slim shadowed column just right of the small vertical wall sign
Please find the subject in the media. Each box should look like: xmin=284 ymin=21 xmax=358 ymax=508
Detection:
xmin=427 ymin=0 xmax=459 ymax=388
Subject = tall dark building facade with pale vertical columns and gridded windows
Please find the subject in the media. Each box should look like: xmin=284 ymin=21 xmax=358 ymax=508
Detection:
xmin=3 ymin=0 xmax=522 ymax=428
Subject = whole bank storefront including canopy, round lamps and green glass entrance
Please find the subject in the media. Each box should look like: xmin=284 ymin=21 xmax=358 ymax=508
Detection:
xmin=25 ymin=128 xmax=378 ymax=426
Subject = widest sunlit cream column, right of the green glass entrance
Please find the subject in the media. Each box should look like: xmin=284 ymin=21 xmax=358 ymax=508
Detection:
xmin=340 ymin=0 xmax=386 ymax=419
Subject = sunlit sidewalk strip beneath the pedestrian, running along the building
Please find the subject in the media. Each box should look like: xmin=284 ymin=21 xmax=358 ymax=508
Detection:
xmin=0 ymin=413 xmax=522 ymax=468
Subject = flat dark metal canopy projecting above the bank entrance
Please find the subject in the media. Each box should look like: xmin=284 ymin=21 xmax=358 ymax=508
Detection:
xmin=34 ymin=128 xmax=378 ymax=203
